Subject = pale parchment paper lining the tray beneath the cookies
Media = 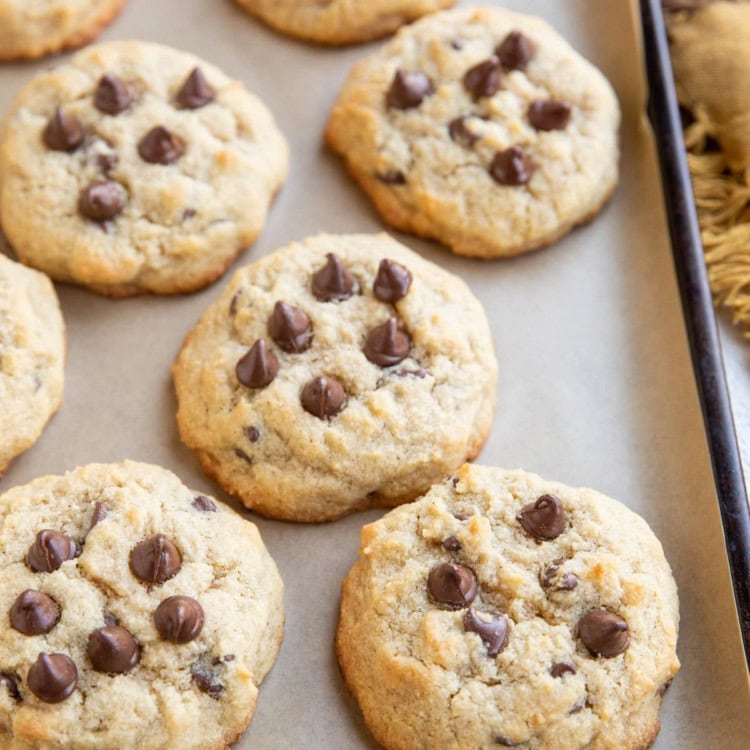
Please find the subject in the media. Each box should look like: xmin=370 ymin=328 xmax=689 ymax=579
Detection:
xmin=0 ymin=0 xmax=750 ymax=750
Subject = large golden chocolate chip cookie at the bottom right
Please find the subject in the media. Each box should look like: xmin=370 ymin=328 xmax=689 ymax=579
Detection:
xmin=337 ymin=465 xmax=679 ymax=750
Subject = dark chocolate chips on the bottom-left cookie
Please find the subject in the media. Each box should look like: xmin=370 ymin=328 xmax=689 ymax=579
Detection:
xmin=0 ymin=495 xmax=220 ymax=703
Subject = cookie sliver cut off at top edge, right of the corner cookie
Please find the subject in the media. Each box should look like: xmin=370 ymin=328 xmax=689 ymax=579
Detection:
xmin=236 ymin=0 xmax=456 ymax=44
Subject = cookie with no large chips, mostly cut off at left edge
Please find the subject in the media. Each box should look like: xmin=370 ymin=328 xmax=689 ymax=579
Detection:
xmin=0 ymin=254 xmax=65 ymax=476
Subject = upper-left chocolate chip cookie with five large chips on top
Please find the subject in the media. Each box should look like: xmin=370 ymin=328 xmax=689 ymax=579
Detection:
xmin=0 ymin=42 xmax=288 ymax=296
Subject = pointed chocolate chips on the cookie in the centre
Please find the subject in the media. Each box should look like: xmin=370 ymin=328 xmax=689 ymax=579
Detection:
xmin=235 ymin=253 xmax=424 ymax=426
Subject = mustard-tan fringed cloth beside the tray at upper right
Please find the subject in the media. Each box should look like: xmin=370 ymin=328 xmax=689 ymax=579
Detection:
xmin=668 ymin=2 xmax=750 ymax=338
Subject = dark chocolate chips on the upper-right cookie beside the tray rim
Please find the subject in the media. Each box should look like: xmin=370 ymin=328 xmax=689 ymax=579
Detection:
xmin=384 ymin=31 xmax=572 ymax=186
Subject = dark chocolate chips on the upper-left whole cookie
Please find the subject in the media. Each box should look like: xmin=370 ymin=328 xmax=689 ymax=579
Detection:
xmin=42 ymin=68 xmax=216 ymax=223
